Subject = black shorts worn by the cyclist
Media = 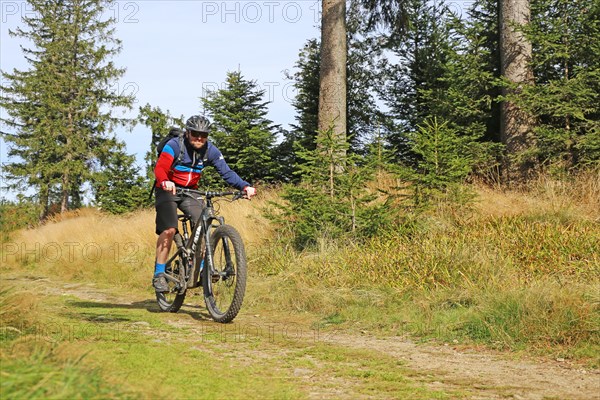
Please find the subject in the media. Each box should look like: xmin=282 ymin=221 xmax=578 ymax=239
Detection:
xmin=154 ymin=188 xmax=204 ymax=235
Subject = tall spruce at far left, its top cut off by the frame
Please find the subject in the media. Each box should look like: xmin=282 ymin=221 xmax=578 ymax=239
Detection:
xmin=1 ymin=0 xmax=133 ymax=217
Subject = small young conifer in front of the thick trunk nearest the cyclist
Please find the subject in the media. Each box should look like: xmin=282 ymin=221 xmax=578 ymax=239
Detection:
xmin=271 ymin=129 xmax=393 ymax=249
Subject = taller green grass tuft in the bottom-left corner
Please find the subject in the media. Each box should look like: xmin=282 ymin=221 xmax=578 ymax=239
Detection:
xmin=0 ymin=287 xmax=133 ymax=399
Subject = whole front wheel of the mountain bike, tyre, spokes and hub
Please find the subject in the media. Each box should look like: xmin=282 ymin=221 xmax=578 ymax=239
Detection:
xmin=202 ymin=225 xmax=246 ymax=323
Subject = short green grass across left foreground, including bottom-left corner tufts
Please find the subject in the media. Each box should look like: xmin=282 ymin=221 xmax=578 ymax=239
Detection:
xmin=0 ymin=287 xmax=450 ymax=399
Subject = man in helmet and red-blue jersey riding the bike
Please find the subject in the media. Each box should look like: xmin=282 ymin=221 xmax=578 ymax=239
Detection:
xmin=152 ymin=115 xmax=256 ymax=292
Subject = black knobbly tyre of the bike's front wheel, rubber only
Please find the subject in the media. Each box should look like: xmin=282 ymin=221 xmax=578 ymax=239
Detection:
xmin=202 ymin=225 xmax=246 ymax=323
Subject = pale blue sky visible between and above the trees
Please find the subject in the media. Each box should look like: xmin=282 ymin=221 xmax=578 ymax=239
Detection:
xmin=0 ymin=0 xmax=321 ymax=197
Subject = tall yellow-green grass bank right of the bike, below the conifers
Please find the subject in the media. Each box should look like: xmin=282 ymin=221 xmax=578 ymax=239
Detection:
xmin=245 ymin=174 xmax=600 ymax=367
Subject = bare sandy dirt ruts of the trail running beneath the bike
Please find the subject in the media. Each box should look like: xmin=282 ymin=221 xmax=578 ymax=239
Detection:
xmin=3 ymin=277 xmax=600 ymax=399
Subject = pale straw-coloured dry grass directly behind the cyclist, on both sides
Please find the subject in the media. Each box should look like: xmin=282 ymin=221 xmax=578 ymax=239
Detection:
xmin=1 ymin=192 xmax=276 ymax=287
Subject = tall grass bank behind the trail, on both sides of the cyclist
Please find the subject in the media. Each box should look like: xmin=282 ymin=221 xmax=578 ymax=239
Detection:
xmin=2 ymin=172 xmax=600 ymax=372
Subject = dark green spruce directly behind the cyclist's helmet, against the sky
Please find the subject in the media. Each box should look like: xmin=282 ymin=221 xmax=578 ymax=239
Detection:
xmin=202 ymin=72 xmax=280 ymax=183
